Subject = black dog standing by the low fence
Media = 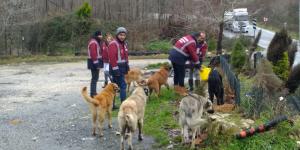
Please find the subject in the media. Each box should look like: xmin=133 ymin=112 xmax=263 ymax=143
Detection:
xmin=208 ymin=69 xmax=224 ymax=105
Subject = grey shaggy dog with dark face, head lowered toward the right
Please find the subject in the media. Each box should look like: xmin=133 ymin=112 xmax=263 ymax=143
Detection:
xmin=179 ymin=94 xmax=214 ymax=149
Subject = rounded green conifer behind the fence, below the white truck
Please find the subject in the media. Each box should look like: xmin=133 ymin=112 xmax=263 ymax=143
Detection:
xmin=231 ymin=40 xmax=246 ymax=71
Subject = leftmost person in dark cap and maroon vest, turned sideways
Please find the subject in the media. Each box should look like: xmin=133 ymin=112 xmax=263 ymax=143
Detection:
xmin=87 ymin=30 xmax=103 ymax=97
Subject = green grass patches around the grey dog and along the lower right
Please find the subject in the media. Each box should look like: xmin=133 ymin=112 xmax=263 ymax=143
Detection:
xmin=109 ymin=76 xmax=300 ymax=150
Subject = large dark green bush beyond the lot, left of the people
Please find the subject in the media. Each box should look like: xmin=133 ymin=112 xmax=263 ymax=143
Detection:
xmin=25 ymin=3 xmax=95 ymax=55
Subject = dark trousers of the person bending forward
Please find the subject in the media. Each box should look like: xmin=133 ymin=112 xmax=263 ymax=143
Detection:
xmin=172 ymin=62 xmax=185 ymax=87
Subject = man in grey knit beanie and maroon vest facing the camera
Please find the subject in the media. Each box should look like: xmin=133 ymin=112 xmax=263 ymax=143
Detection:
xmin=108 ymin=27 xmax=129 ymax=109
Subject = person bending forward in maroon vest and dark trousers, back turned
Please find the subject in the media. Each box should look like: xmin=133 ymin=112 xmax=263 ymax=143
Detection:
xmin=169 ymin=32 xmax=201 ymax=95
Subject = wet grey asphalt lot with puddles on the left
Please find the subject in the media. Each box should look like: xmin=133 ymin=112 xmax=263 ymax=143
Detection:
xmin=0 ymin=60 xmax=166 ymax=150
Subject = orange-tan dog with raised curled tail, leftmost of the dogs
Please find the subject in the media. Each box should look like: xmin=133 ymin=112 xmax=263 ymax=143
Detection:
xmin=81 ymin=83 xmax=119 ymax=136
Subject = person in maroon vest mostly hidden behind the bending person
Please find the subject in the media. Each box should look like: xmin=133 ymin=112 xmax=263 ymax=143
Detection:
xmin=188 ymin=32 xmax=208 ymax=91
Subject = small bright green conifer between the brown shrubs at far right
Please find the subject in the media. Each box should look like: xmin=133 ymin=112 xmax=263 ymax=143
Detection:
xmin=273 ymin=52 xmax=289 ymax=81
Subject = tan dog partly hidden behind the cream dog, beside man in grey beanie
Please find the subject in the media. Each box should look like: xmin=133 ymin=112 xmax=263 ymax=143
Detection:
xmin=125 ymin=68 xmax=143 ymax=92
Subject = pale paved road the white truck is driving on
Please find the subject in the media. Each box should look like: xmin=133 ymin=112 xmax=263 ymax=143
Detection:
xmin=224 ymin=26 xmax=300 ymax=66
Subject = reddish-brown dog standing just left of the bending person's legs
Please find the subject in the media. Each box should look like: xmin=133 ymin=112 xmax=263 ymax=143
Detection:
xmin=147 ymin=65 xmax=171 ymax=96
